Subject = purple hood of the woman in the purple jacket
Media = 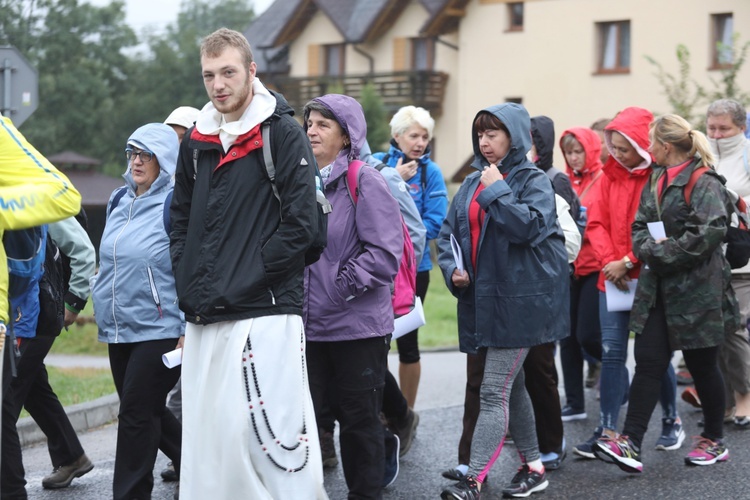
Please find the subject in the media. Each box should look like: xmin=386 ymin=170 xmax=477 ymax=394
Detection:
xmin=304 ymin=94 xmax=367 ymax=182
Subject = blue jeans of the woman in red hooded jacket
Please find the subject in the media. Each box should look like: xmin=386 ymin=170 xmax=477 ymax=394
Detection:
xmin=599 ymin=292 xmax=677 ymax=430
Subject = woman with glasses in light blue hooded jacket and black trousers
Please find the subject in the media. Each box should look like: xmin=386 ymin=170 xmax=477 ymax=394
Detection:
xmin=92 ymin=123 xmax=185 ymax=499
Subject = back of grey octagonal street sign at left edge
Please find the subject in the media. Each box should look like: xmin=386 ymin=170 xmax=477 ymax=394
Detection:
xmin=0 ymin=46 xmax=39 ymax=127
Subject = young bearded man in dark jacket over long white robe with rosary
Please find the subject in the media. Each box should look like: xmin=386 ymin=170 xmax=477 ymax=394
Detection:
xmin=170 ymin=28 xmax=326 ymax=500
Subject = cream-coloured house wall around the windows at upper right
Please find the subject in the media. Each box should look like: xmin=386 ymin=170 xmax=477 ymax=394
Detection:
xmin=450 ymin=0 xmax=750 ymax=176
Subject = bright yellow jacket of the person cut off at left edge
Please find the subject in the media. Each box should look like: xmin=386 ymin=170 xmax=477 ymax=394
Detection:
xmin=0 ymin=115 xmax=81 ymax=492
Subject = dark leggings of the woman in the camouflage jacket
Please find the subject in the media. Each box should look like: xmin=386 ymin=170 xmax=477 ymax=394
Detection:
xmin=622 ymin=297 xmax=725 ymax=448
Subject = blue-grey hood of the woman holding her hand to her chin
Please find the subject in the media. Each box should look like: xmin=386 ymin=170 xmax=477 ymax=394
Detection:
xmin=471 ymin=102 xmax=531 ymax=173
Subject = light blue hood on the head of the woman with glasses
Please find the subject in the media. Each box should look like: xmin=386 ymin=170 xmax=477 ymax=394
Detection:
xmin=123 ymin=123 xmax=180 ymax=195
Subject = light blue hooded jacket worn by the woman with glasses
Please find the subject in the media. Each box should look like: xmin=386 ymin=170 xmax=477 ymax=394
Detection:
xmin=91 ymin=123 xmax=185 ymax=343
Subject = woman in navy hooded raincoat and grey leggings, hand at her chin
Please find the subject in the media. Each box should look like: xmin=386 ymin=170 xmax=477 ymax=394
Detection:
xmin=438 ymin=104 xmax=569 ymax=499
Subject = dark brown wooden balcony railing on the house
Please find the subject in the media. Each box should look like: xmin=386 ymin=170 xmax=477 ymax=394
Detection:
xmin=268 ymin=71 xmax=448 ymax=117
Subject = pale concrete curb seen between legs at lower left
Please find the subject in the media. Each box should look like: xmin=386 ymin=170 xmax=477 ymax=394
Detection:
xmin=16 ymin=393 xmax=120 ymax=447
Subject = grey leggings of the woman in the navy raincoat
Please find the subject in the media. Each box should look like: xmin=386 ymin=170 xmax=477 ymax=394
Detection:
xmin=469 ymin=347 xmax=540 ymax=482
